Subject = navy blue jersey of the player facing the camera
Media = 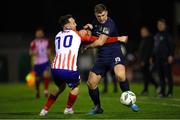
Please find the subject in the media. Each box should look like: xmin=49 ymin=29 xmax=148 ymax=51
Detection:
xmin=92 ymin=17 xmax=121 ymax=61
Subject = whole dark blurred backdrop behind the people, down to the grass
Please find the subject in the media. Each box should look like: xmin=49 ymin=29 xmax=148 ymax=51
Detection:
xmin=0 ymin=0 xmax=180 ymax=84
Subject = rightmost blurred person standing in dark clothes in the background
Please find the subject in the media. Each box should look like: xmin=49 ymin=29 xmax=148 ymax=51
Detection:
xmin=153 ymin=19 xmax=175 ymax=97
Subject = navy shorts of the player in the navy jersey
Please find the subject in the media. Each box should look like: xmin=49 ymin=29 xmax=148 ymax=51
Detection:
xmin=91 ymin=51 xmax=125 ymax=77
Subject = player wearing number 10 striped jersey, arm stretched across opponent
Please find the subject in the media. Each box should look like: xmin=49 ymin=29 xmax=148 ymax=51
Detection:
xmin=39 ymin=15 xmax=127 ymax=116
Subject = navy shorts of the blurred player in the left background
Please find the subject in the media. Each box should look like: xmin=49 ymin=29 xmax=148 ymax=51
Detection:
xmin=34 ymin=61 xmax=50 ymax=76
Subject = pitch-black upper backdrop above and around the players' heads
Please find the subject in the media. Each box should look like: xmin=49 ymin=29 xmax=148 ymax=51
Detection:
xmin=0 ymin=0 xmax=175 ymax=51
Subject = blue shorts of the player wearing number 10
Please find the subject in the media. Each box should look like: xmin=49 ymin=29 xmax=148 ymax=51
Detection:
xmin=52 ymin=69 xmax=80 ymax=89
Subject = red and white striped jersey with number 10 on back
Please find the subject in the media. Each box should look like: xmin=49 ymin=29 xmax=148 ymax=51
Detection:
xmin=51 ymin=30 xmax=81 ymax=71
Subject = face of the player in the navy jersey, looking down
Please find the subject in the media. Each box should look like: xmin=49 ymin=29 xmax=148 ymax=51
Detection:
xmin=95 ymin=11 xmax=108 ymax=23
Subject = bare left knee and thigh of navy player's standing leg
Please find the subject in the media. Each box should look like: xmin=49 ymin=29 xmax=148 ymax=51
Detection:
xmin=87 ymin=71 xmax=101 ymax=88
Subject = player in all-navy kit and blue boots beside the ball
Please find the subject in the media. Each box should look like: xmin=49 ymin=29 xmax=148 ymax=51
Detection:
xmin=84 ymin=4 xmax=139 ymax=114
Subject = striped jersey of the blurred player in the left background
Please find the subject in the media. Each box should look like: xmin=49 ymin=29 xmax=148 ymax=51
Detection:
xmin=30 ymin=38 xmax=49 ymax=64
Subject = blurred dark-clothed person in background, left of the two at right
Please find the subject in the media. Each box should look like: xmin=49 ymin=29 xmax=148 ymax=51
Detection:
xmin=138 ymin=26 xmax=158 ymax=95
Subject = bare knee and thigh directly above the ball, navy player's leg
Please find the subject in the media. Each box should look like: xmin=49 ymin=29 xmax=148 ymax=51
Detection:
xmin=114 ymin=64 xmax=126 ymax=81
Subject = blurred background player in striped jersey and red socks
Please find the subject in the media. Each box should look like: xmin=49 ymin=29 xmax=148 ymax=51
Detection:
xmin=30 ymin=28 xmax=50 ymax=98
